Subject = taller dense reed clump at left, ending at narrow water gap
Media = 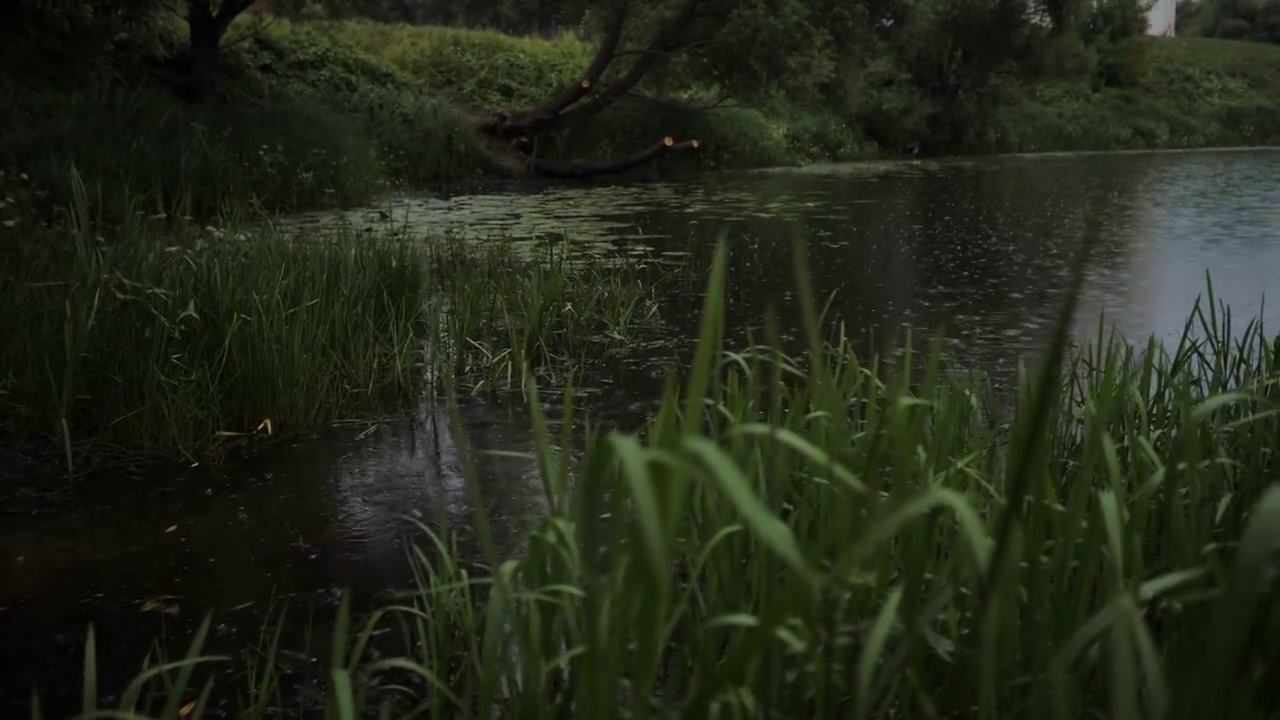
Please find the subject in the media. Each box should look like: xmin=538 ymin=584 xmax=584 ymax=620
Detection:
xmin=0 ymin=176 xmax=430 ymax=455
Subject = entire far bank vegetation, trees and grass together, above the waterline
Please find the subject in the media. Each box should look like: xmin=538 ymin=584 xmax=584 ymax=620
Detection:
xmin=0 ymin=0 xmax=1280 ymax=214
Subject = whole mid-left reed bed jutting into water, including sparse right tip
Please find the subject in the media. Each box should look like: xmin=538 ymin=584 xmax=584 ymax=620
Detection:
xmin=0 ymin=176 xmax=675 ymax=464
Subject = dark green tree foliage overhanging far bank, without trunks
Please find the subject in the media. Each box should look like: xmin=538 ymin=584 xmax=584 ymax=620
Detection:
xmin=276 ymin=0 xmax=1167 ymax=150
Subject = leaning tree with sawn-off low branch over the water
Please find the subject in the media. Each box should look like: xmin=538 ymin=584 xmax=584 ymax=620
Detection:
xmin=475 ymin=0 xmax=835 ymax=177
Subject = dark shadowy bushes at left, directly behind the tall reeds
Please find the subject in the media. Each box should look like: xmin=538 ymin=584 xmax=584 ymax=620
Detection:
xmin=0 ymin=80 xmax=385 ymax=215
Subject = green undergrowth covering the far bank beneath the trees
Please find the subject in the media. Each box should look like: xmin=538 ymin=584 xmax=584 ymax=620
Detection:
xmin=0 ymin=19 xmax=1280 ymax=217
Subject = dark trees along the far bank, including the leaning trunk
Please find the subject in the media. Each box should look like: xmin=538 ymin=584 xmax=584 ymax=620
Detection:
xmin=0 ymin=0 xmax=1162 ymax=163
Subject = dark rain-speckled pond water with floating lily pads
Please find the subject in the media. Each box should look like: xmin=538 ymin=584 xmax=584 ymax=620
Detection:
xmin=0 ymin=150 xmax=1280 ymax=717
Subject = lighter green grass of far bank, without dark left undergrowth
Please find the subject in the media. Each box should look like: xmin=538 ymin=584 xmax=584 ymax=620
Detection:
xmin=322 ymin=20 xmax=1280 ymax=156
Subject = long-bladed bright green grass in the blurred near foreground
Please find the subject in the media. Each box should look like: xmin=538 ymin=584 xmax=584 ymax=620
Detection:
xmin=40 ymin=243 xmax=1280 ymax=720
